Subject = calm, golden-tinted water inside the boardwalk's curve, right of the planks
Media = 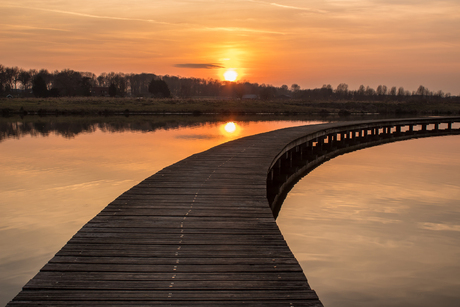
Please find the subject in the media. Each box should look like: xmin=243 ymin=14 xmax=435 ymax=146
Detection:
xmin=277 ymin=136 xmax=460 ymax=307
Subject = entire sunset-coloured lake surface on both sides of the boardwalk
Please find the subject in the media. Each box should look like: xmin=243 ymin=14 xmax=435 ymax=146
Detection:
xmin=0 ymin=118 xmax=460 ymax=307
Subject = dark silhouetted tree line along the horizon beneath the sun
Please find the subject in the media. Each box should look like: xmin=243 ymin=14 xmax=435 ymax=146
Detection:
xmin=0 ymin=64 xmax=458 ymax=101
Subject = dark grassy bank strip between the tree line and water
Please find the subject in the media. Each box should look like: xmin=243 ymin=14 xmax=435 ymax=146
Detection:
xmin=0 ymin=97 xmax=460 ymax=116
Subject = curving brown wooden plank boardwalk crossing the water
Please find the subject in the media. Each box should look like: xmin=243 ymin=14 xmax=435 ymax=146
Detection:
xmin=7 ymin=118 xmax=460 ymax=306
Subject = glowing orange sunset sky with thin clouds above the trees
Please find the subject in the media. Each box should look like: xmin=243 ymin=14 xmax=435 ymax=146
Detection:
xmin=0 ymin=0 xmax=460 ymax=95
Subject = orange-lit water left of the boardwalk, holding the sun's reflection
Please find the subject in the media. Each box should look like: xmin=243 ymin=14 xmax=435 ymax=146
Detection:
xmin=0 ymin=118 xmax=318 ymax=306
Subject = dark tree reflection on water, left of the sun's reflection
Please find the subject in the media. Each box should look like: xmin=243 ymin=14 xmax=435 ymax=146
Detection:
xmin=0 ymin=117 xmax=218 ymax=141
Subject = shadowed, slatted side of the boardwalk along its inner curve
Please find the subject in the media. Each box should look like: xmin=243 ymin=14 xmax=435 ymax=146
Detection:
xmin=267 ymin=117 xmax=460 ymax=217
